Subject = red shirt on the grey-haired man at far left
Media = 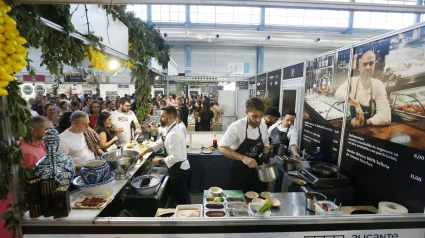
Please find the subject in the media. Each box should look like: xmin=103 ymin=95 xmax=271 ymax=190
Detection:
xmin=20 ymin=138 xmax=47 ymax=168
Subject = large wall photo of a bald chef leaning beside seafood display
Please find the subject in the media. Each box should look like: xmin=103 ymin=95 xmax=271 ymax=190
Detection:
xmin=335 ymin=24 xmax=425 ymax=150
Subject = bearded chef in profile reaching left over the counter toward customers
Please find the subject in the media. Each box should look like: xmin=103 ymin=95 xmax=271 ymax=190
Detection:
xmin=139 ymin=106 xmax=191 ymax=205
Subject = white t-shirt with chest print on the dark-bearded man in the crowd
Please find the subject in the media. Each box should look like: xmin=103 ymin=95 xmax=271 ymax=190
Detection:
xmin=111 ymin=110 xmax=139 ymax=146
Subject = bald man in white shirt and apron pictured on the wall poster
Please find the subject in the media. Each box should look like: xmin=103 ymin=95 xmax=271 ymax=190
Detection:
xmin=335 ymin=51 xmax=391 ymax=128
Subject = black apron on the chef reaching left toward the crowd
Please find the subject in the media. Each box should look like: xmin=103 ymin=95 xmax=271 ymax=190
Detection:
xmin=161 ymin=123 xmax=191 ymax=205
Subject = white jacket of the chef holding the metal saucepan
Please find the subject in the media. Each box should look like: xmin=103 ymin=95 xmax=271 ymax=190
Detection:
xmin=218 ymin=117 xmax=270 ymax=151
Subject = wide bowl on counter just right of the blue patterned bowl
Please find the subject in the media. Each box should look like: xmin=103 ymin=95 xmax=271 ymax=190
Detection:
xmin=100 ymin=150 xmax=140 ymax=177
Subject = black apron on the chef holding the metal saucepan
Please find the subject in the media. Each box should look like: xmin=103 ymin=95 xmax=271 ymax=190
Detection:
xmin=230 ymin=122 xmax=267 ymax=193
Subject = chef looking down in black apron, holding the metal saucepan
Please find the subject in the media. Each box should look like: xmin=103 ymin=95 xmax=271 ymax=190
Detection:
xmin=218 ymin=97 xmax=270 ymax=193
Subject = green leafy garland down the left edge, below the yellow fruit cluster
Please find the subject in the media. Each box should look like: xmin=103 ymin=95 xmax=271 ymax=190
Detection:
xmin=0 ymin=81 xmax=31 ymax=232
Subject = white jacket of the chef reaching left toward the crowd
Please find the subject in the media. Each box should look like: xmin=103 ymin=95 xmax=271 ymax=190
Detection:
xmin=150 ymin=122 xmax=190 ymax=170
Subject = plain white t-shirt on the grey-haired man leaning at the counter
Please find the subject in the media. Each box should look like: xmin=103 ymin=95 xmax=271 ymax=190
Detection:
xmin=59 ymin=129 xmax=95 ymax=164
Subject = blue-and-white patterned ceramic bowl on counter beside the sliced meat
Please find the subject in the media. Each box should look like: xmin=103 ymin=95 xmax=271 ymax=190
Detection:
xmin=80 ymin=160 xmax=109 ymax=184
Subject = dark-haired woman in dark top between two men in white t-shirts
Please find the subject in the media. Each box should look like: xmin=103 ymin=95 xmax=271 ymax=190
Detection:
xmin=94 ymin=111 xmax=118 ymax=150
